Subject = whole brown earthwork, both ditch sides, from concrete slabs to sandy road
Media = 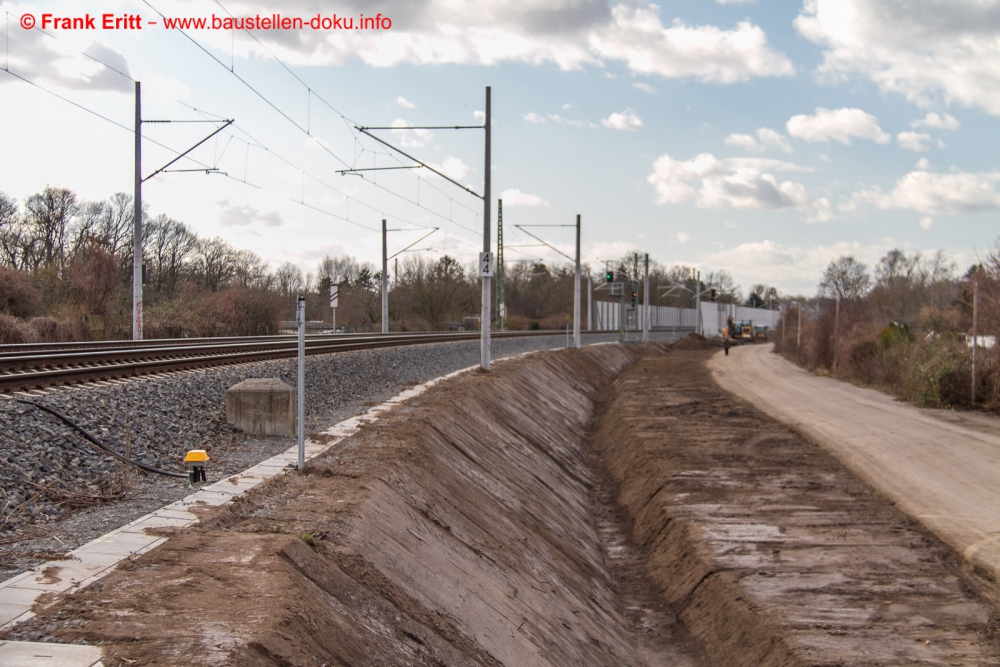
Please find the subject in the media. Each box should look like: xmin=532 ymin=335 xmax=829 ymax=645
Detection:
xmin=1 ymin=339 xmax=1000 ymax=667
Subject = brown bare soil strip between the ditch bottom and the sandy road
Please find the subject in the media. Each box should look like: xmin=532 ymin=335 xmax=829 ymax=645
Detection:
xmin=595 ymin=344 xmax=1000 ymax=667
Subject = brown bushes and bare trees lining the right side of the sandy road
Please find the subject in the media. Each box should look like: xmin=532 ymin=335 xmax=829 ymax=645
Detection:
xmin=777 ymin=245 xmax=1000 ymax=411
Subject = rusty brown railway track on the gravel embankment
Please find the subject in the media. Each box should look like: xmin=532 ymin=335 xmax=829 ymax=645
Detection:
xmin=0 ymin=331 xmax=592 ymax=393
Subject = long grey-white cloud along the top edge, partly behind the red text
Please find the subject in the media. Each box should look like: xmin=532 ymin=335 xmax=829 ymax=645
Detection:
xmin=203 ymin=0 xmax=794 ymax=83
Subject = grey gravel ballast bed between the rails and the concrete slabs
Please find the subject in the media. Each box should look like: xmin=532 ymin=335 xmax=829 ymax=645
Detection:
xmin=0 ymin=333 xmax=670 ymax=579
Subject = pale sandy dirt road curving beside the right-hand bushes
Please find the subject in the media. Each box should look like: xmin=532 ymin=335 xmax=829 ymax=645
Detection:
xmin=709 ymin=345 xmax=1000 ymax=581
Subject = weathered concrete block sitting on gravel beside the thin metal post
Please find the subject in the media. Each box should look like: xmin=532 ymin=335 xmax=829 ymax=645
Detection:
xmin=226 ymin=378 xmax=295 ymax=437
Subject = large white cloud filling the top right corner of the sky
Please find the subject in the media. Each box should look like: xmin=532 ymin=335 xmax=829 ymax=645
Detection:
xmin=795 ymin=0 xmax=1000 ymax=115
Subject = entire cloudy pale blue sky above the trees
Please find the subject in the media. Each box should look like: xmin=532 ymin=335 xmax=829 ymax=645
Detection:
xmin=0 ymin=0 xmax=1000 ymax=294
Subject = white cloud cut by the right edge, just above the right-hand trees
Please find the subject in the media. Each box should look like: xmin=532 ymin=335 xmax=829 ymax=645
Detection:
xmin=844 ymin=170 xmax=1000 ymax=215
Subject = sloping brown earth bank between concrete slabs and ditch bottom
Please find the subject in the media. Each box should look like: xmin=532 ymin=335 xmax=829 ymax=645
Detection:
xmin=7 ymin=345 xmax=701 ymax=667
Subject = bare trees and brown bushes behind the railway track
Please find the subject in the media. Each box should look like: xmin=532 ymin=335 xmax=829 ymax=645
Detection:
xmin=0 ymin=187 xmax=777 ymax=342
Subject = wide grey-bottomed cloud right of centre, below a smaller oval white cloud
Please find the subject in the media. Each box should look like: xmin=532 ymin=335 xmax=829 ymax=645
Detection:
xmin=646 ymin=153 xmax=832 ymax=222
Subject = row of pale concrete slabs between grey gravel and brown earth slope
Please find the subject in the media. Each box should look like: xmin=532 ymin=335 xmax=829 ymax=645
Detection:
xmin=0 ymin=350 xmax=564 ymax=667
